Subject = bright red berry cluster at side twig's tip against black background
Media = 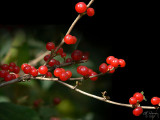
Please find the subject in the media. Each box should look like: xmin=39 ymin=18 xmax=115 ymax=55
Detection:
xmin=99 ymin=56 xmax=126 ymax=73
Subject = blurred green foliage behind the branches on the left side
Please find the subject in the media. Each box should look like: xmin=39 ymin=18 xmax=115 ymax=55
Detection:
xmin=0 ymin=25 xmax=112 ymax=120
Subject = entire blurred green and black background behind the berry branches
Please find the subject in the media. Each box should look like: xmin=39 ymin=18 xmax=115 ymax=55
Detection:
xmin=0 ymin=0 xmax=160 ymax=120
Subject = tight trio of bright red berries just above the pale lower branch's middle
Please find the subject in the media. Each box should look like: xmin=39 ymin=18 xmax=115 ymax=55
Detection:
xmin=53 ymin=68 xmax=72 ymax=81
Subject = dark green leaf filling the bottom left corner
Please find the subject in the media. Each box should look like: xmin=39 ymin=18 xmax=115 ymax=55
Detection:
xmin=0 ymin=103 xmax=40 ymax=120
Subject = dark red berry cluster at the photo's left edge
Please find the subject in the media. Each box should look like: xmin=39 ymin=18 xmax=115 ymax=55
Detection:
xmin=0 ymin=62 xmax=20 ymax=81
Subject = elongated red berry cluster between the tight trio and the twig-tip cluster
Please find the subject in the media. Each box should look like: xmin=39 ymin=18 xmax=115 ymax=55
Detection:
xmin=77 ymin=66 xmax=98 ymax=81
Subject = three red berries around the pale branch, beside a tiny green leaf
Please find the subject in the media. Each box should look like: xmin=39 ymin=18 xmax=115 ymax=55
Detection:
xmin=129 ymin=92 xmax=144 ymax=116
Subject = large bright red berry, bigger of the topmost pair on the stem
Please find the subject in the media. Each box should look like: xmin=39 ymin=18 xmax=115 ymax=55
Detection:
xmin=75 ymin=2 xmax=87 ymax=13
